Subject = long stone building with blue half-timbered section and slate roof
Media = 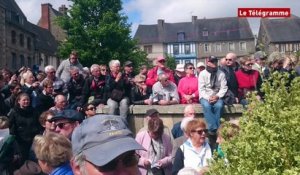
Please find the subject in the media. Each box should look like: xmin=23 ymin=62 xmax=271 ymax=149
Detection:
xmin=134 ymin=16 xmax=255 ymax=64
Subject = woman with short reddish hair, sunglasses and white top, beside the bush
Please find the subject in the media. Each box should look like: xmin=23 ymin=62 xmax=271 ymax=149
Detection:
xmin=172 ymin=119 xmax=212 ymax=174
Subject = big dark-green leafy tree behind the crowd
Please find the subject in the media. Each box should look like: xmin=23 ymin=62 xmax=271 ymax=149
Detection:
xmin=57 ymin=0 xmax=146 ymax=66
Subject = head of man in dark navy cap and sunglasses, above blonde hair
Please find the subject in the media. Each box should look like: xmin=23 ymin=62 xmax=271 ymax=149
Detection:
xmin=49 ymin=109 xmax=83 ymax=139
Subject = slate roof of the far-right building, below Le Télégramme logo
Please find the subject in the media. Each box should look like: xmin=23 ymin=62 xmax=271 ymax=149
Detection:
xmin=261 ymin=16 xmax=300 ymax=43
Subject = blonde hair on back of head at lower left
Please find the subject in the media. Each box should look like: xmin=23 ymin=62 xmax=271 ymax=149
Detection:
xmin=33 ymin=132 xmax=72 ymax=168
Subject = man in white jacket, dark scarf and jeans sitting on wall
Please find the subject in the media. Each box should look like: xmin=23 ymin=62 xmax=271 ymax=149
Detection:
xmin=198 ymin=56 xmax=228 ymax=148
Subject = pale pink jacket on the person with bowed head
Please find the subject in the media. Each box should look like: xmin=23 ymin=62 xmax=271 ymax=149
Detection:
xmin=135 ymin=131 xmax=173 ymax=175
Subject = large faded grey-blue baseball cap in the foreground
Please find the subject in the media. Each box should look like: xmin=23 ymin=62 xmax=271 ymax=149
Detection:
xmin=72 ymin=114 xmax=144 ymax=166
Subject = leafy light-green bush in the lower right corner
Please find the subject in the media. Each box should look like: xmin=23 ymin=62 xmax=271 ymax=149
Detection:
xmin=207 ymin=73 xmax=300 ymax=175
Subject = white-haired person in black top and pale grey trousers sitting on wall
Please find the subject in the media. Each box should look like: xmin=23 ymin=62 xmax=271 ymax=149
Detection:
xmin=107 ymin=60 xmax=130 ymax=118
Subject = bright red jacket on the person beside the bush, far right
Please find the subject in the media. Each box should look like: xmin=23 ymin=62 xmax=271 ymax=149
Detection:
xmin=235 ymin=69 xmax=261 ymax=99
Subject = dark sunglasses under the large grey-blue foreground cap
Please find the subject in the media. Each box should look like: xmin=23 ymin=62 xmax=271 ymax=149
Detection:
xmin=95 ymin=151 xmax=140 ymax=172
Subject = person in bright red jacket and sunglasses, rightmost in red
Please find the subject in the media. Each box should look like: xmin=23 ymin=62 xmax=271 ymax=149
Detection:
xmin=235 ymin=56 xmax=262 ymax=106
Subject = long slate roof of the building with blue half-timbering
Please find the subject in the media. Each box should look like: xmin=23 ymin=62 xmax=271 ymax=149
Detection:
xmin=134 ymin=17 xmax=254 ymax=44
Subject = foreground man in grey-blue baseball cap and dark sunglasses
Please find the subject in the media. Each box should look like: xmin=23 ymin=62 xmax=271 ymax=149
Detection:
xmin=71 ymin=115 xmax=144 ymax=175
